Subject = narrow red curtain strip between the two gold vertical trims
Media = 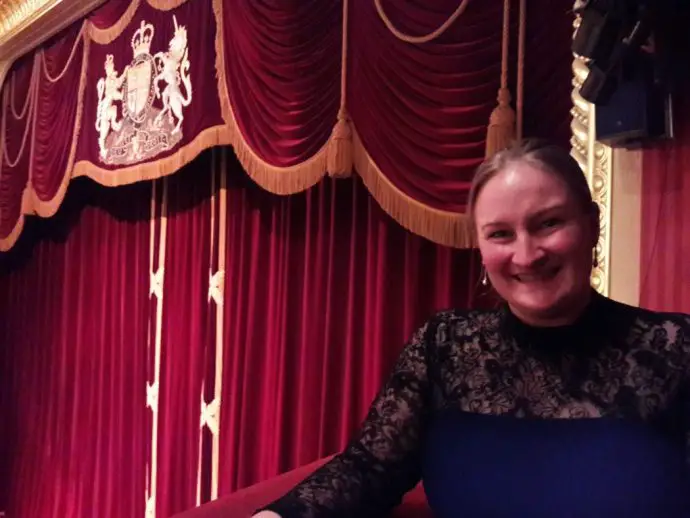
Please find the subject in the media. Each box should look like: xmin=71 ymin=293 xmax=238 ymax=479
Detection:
xmin=156 ymin=156 xmax=215 ymax=517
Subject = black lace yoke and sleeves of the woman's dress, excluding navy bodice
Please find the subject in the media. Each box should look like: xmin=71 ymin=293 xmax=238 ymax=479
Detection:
xmin=260 ymin=295 xmax=690 ymax=518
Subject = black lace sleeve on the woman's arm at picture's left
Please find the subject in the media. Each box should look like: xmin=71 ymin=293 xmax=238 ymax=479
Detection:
xmin=265 ymin=316 xmax=432 ymax=518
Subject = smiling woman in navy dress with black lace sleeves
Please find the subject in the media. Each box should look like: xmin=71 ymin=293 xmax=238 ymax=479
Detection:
xmin=256 ymin=141 xmax=690 ymax=518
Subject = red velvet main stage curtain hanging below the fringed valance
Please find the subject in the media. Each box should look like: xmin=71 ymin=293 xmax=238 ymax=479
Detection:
xmin=0 ymin=150 xmax=484 ymax=518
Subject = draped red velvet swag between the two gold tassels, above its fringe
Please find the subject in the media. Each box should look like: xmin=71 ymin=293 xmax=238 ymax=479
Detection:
xmin=348 ymin=0 xmax=503 ymax=211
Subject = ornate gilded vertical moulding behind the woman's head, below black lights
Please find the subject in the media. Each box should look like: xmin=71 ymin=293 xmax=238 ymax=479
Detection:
xmin=570 ymin=11 xmax=613 ymax=295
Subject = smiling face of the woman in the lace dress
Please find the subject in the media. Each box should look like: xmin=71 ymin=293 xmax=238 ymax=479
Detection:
xmin=474 ymin=161 xmax=599 ymax=325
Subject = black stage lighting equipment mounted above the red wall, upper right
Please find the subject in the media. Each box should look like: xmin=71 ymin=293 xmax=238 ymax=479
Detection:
xmin=572 ymin=0 xmax=676 ymax=147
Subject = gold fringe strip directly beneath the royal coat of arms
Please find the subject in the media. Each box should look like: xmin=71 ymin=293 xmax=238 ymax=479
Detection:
xmin=72 ymin=126 xmax=230 ymax=187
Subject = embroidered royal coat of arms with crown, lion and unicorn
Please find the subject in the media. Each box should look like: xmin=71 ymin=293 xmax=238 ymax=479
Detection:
xmin=96 ymin=16 xmax=192 ymax=165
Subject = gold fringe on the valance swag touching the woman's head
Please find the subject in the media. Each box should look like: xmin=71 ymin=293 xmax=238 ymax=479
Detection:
xmin=352 ymin=128 xmax=474 ymax=252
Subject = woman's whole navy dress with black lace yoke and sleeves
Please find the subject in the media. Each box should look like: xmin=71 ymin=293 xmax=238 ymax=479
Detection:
xmin=268 ymin=295 xmax=690 ymax=518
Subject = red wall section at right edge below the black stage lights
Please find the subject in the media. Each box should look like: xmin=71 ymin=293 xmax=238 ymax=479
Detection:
xmin=636 ymin=92 xmax=690 ymax=313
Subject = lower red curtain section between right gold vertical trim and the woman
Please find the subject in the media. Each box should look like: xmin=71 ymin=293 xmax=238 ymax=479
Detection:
xmin=220 ymin=152 xmax=488 ymax=494
